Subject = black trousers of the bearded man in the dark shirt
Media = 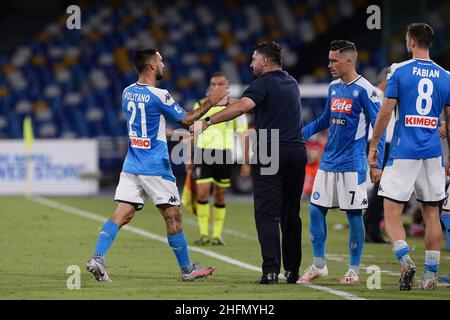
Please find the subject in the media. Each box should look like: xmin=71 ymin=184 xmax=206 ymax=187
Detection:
xmin=252 ymin=144 xmax=306 ymax=274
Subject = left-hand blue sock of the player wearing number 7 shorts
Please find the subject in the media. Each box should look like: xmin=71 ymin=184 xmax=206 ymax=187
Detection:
xmin=309 ymin=203 xmax=328 ymax=268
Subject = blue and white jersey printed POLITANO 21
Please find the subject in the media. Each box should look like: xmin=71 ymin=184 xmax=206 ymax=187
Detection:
xmin=122 ymin=82 xmax=186 ymax=181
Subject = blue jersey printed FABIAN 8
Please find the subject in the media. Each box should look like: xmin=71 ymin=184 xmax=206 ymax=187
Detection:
xmin=385 ymin=59 xmax=450 ymax=159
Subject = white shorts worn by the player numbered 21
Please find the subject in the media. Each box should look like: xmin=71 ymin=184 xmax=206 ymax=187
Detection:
xmin=114 ymin=172 xmax=180 ymax=210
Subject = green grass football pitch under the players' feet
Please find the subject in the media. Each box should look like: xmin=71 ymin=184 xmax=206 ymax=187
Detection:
xmin=0 ymin=197 xmax=450 ymax=300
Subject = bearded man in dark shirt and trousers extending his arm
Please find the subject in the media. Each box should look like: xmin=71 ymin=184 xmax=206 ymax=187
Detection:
xmin=202 ymin=42 xmax=306 ymax=284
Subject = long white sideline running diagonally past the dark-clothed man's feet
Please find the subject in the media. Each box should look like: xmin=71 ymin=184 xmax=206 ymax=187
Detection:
xmin=29 ymin=196 xmax=367 ymax=300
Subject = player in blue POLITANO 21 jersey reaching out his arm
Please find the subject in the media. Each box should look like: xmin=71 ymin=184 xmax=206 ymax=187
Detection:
xmin=86 ymin=48 xmax=228 ymax=282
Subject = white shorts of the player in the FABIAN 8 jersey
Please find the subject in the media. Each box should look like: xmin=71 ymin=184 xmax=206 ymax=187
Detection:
xmin=378 ymin=157 xmax=445 ymax=202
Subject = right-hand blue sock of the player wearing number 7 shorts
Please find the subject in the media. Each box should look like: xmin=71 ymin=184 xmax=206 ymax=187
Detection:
xmin=347 ymin=210 xmax=366 ymax=272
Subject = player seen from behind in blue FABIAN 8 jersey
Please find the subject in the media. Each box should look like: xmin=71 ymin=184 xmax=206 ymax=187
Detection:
xmin=368 ymin=23 xmax=450 ymax=291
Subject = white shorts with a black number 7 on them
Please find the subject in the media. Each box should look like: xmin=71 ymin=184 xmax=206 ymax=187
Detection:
xmin=311 ymin=169 xmax=368 ymax=210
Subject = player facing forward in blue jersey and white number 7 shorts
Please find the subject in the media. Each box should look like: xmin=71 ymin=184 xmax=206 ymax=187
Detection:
xmin=298 ymin=40 xmax=385 ymax=285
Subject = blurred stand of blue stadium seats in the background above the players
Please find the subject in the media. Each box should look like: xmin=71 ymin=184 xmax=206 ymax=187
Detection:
xmin=0 ymin=0 xmax=450 ymax=138
